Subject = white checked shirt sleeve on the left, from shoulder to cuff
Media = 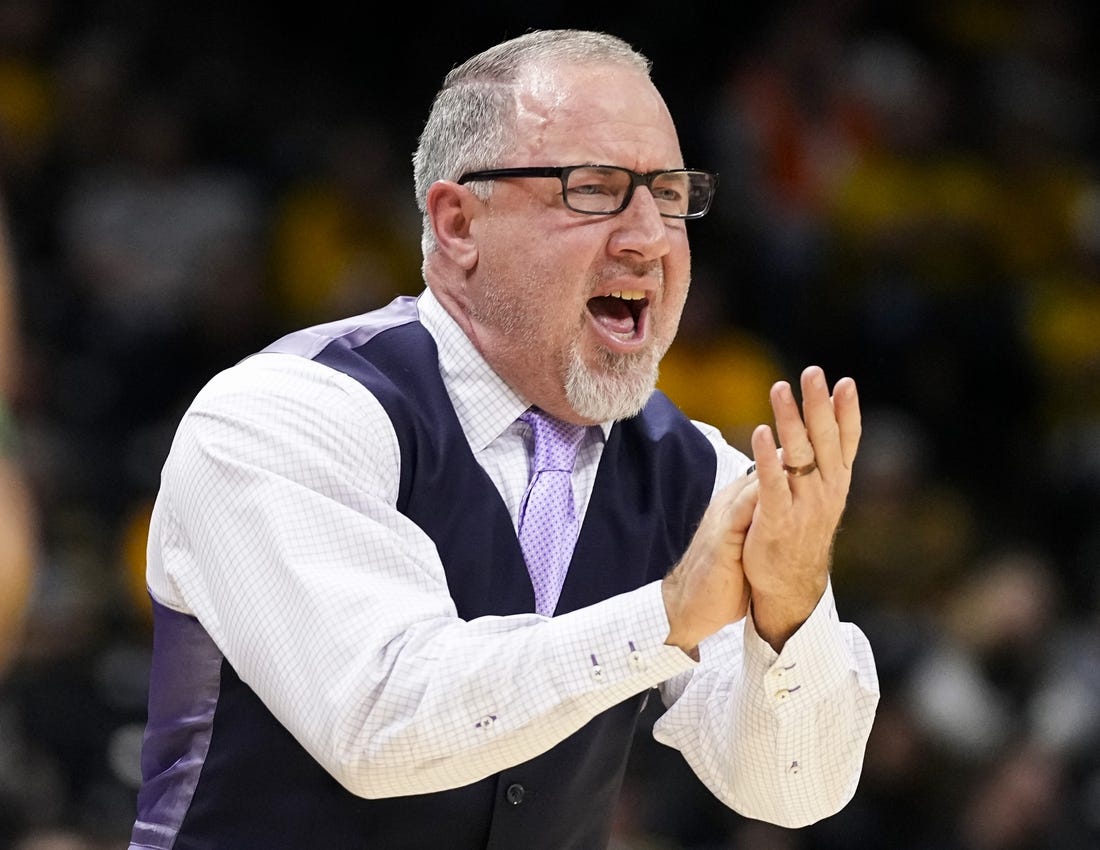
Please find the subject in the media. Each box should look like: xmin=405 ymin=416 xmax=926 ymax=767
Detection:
xmin=149 ymin=354 xmax=693 ymax=797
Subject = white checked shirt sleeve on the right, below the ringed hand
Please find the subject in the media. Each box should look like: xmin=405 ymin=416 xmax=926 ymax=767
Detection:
xmin=653 ymin=420 xmax=879 ymax=827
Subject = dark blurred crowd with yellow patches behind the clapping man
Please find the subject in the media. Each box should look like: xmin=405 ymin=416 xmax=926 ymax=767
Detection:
xmin=0 ymin=0 xmax=1100 ymax=850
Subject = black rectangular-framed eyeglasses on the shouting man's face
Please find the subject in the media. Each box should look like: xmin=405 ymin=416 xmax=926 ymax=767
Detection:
xmin=459 ymin=165 xmax=718 ymax=219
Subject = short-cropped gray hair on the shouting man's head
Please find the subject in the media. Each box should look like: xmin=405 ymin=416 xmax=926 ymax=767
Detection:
xmin=413 ymin=30 xmax=651 ymax=257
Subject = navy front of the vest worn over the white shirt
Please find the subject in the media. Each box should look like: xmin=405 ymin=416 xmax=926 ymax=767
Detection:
xmin=137 ymin=301 xmax=715 ymax=850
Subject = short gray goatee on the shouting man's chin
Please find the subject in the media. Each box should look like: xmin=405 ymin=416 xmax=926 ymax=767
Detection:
xmin=565 ymin=334 xmax=664 ymax=422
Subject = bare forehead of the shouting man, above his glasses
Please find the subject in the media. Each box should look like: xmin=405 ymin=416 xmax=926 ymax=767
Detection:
xmin=516 ymin=64 xmax=683 ymax=170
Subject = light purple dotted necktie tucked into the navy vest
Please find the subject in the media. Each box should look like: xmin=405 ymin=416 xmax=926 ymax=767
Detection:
xmin=519 ymin=408 xmax=585 ymax=617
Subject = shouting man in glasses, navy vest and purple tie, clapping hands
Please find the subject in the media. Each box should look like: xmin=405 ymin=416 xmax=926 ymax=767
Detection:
xmin=132 ymin=31 xmax=878 ymax=850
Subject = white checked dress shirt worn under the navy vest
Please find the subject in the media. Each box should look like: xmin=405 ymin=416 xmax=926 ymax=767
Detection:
xmin=147 ymin=290 xmax=878 ymax=826
